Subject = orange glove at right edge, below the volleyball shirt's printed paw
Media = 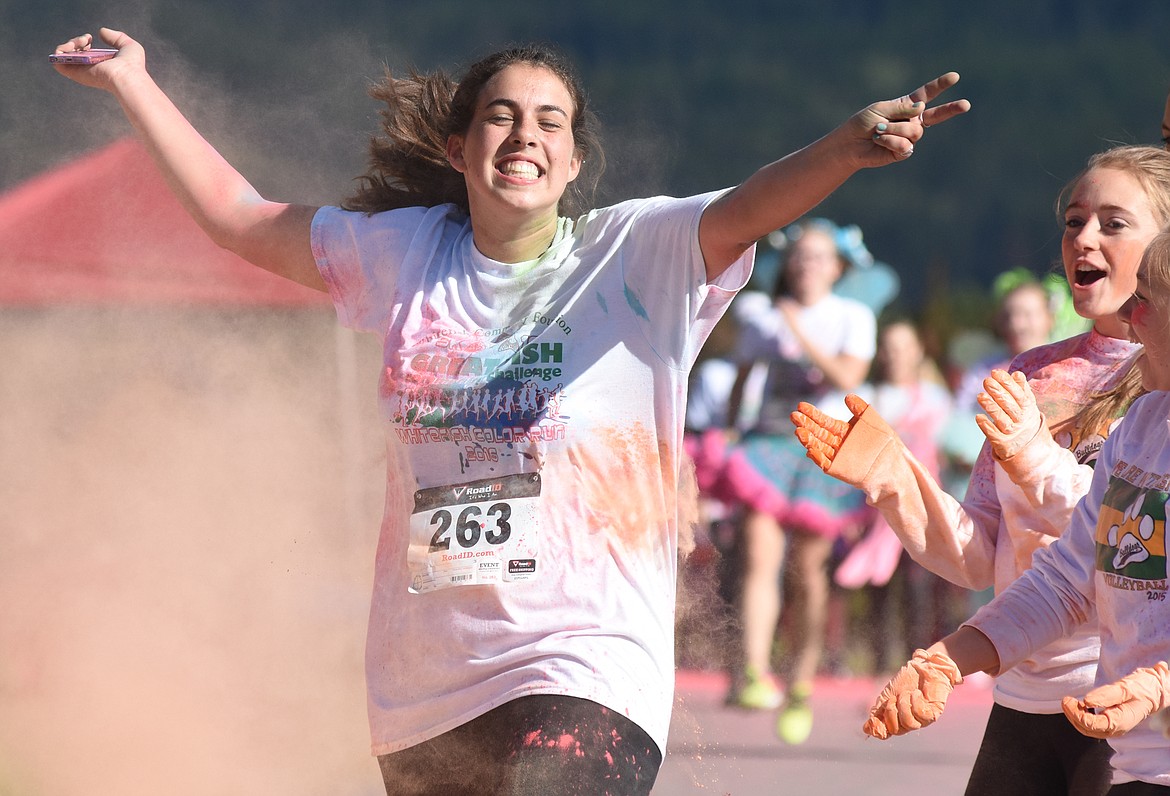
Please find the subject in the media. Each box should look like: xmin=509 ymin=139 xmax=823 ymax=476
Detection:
xmin=1060 ymin=661 xmax=1170 ymax=737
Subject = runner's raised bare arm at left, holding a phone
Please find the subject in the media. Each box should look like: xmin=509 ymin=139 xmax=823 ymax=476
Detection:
xmin=55 ymin=28 xmax=325 ymax=290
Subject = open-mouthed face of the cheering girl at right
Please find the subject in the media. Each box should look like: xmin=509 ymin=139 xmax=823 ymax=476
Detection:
xmin=1061 ymin=169 xmax=1159 ymax=337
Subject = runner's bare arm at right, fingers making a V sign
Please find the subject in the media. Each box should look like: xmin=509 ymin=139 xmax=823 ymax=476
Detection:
xmin=698 ymin=71 xmax=971 ymax=279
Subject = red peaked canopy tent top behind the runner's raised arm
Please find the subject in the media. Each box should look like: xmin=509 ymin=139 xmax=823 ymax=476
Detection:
xmin=0 ymin=138 xmax=329 ymax=307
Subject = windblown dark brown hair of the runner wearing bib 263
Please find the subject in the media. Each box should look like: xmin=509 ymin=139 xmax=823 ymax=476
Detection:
xmin=342 ymin=44 xmax=605 ymax=215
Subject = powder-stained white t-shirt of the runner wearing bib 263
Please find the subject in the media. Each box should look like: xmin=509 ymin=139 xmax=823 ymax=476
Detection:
xmin=312 ymin=193 xmax=753 ymax=754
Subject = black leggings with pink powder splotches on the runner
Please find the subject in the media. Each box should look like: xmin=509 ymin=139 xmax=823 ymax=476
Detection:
xmin=378 ymin=694 xmax=662 ymax=796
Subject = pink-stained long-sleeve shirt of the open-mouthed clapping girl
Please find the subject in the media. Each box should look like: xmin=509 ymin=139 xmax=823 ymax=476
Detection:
xmin=830 ymin=331 xmax=1137 ymax=713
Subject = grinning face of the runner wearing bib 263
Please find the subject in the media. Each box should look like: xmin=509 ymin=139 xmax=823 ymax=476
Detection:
xmin=447 ymin=63 xmax=580 ymax=231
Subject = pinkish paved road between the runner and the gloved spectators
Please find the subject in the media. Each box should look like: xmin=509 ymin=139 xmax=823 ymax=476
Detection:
xmin=654 ymin=671 xmax=991 ymax=796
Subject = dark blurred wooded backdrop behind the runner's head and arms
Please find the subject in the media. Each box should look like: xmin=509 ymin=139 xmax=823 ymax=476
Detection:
xmin=9 ymin=0 xmax=1170 ymax=316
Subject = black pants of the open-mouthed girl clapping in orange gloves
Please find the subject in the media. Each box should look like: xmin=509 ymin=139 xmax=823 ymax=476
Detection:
xmin=966 ymin=705 xmax=1113 ymax=796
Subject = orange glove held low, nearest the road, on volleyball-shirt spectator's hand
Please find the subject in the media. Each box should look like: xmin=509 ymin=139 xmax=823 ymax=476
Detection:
xmin=861 ymin=650 xmax=963 ymax=741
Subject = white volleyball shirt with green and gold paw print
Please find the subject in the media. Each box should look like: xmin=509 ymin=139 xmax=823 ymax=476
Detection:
xmin=968 ymin=392 xmax=1170 ymax=785
